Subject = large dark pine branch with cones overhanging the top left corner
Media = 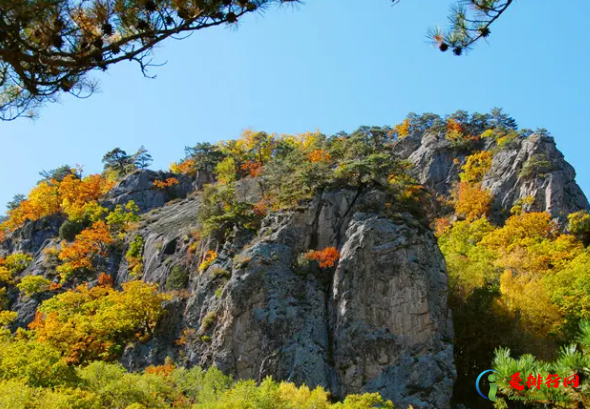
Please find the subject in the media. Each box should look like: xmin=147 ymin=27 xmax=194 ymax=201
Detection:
xmin=0 ymin=0 xmax=298 ymax=120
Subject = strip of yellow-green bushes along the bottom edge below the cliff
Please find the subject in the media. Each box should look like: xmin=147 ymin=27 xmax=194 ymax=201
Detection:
xmin=0 ymin=356 xmax=393 ymax=409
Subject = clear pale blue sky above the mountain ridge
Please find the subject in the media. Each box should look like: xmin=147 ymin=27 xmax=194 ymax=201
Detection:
xmin=0 ymin=0 xmax=590 ymax=211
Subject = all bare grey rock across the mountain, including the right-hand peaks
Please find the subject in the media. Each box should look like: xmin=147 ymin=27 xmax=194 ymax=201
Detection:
xmin=0 ymin=115 xmax=589 ymax=408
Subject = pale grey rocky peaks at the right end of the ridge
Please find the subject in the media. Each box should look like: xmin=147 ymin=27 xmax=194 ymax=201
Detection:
xmin=394 ymin=133 xmax=590 ymax=221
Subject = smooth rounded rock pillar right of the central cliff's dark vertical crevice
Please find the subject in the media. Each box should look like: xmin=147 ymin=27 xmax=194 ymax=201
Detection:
xmin=333 ymin=214 xmax=456 ymax=408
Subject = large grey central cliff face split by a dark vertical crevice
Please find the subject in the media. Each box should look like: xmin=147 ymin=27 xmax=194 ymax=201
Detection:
xmin=122 ymin=190 xmax=456 ymax=408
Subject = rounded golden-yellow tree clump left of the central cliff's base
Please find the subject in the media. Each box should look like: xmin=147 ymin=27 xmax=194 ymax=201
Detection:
xmin=29 ymin=281 xmax=165 ymax=364
